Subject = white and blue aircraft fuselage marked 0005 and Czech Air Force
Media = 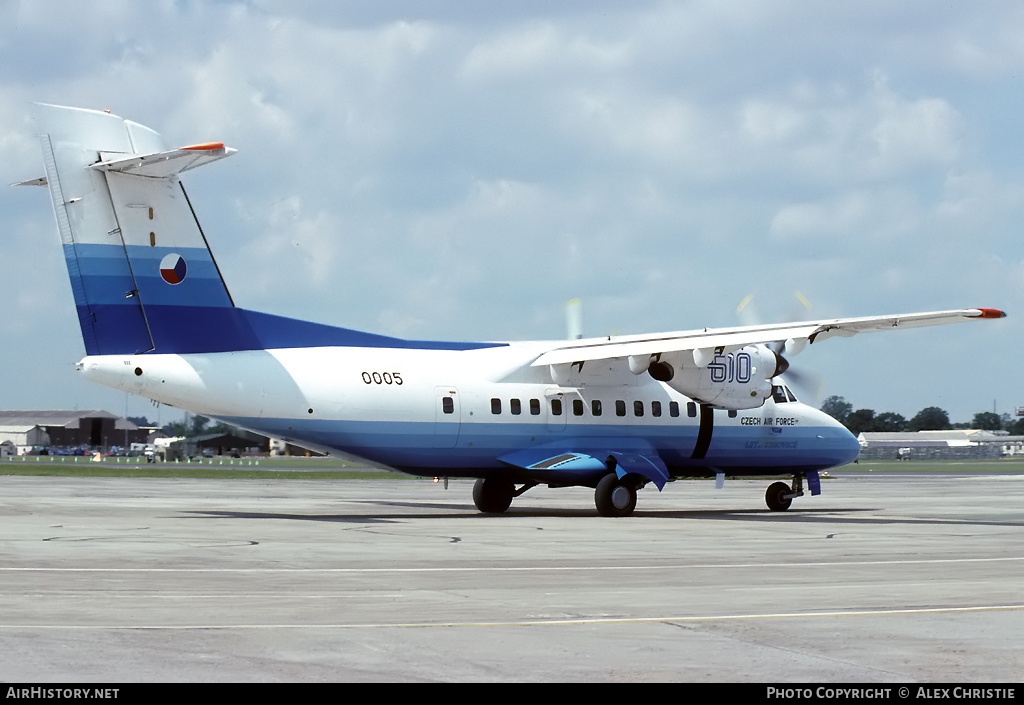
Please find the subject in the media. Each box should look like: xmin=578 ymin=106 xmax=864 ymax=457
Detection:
xmin=79 ymin=342 xmax=859 ymax=485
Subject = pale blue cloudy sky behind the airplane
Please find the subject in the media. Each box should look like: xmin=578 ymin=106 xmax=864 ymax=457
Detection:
xmin=0 ymin=0 xmax=1024 ymax=423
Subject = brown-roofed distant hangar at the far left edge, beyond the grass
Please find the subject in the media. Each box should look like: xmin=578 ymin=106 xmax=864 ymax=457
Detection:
xmin=0 ymin=409 xmax=147 ymax=455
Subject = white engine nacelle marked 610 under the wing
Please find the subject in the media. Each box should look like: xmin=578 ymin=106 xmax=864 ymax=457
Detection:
xmin=648 ymin=345 xmax=787 ymax=409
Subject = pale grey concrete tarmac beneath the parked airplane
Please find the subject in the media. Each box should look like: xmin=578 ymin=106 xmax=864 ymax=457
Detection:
xmin=0 ymin=471 xmax=1024 ymax=685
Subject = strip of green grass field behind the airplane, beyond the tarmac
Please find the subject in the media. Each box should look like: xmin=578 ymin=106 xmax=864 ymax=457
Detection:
xmin=0 ymin=455 xmax=1024 ymax=480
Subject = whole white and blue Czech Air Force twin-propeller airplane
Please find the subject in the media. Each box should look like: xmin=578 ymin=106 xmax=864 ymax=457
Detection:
xmin=22 ymin=105 xmax=1006 ymax=516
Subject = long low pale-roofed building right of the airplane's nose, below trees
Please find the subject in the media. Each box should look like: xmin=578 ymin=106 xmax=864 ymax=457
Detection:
xmin=857 ymin=428 xmax=1024 ymax=460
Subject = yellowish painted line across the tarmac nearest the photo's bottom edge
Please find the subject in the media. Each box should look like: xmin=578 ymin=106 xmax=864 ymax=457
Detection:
xmin=0 ymin=605 xmax=1024 ymax=631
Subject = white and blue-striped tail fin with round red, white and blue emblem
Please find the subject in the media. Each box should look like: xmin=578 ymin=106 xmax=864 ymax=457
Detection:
xmin=38 ymin=101 xmax=238 ymax=355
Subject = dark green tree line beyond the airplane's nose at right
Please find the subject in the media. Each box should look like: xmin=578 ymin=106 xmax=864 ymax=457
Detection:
xmin=820 ymin=396 xmax=1024 ymax=436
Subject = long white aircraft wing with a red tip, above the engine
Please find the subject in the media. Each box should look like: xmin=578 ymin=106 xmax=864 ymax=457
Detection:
xmin=532 ymin=308 xmax=1006 ymax=367
